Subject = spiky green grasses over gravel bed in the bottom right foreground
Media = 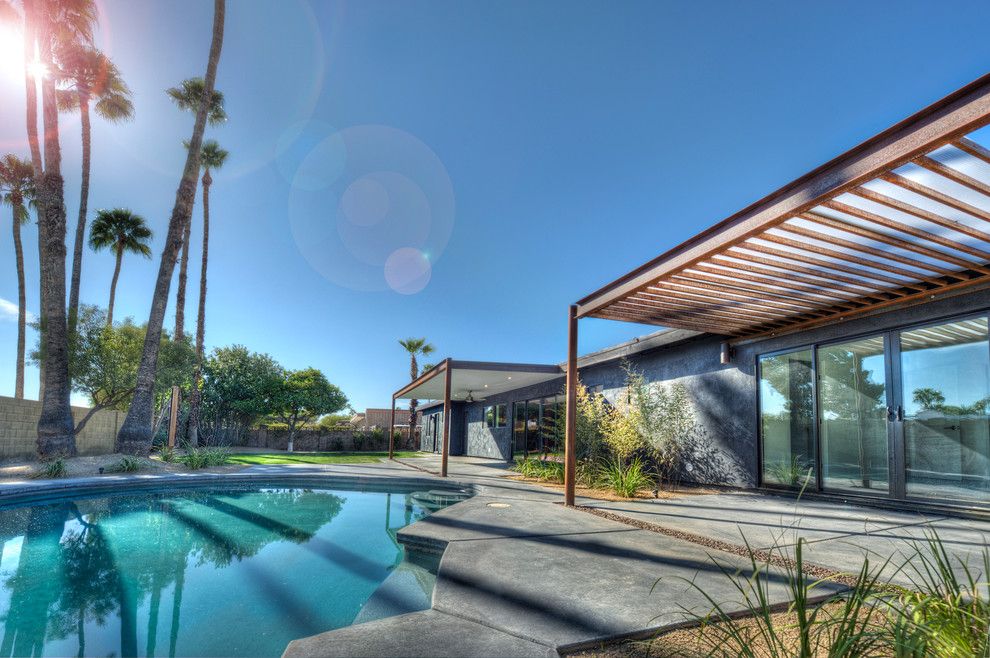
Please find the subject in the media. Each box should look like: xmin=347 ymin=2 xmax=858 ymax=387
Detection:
xmin=676 ymin=531 xmax=990 ymax=658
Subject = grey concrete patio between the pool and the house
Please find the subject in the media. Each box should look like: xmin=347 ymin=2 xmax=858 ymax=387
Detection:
xmin=285 ymin=456 xmax=990 ymax=657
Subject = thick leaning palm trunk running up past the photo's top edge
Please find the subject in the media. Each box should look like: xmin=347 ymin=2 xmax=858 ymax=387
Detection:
xmin=116 ymin=0 xmax=226 ymax=455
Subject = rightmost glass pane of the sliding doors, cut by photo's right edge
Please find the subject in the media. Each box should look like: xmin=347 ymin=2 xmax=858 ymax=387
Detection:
xmin=898 ymin=318 xmax=990 ymax=502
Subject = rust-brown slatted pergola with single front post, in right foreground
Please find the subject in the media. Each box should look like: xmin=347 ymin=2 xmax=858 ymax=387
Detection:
xmin=564 ymin=75 xmax=990 ymax=505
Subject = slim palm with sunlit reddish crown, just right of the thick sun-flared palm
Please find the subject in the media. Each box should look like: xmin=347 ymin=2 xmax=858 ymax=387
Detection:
xmin=56 ymin=46 xmax=134 ymax=336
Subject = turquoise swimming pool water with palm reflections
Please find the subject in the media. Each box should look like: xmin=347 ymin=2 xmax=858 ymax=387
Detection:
xmin=0 ymin=486 xmax=463 ymax=657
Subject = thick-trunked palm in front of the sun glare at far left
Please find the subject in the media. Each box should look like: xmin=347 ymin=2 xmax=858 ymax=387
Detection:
xmin=30 ymin=0 xmax=96 ymax=458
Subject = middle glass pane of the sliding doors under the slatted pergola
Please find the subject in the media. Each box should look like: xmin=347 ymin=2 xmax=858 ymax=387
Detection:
xmin=817 ymin=336 xmax=890 ymax=494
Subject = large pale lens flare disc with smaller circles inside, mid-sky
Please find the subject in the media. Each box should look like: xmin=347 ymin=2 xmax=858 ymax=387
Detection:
xmin=280 ymin=125 xmax=454 ymax=295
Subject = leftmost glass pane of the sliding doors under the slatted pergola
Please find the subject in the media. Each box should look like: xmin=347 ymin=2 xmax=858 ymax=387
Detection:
xmin=759 ymin=349 xmax=817 ymax=488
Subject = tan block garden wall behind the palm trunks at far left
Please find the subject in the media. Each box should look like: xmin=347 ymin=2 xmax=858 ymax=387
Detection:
xmin=0 ymin=396 xmax=126 ymax=459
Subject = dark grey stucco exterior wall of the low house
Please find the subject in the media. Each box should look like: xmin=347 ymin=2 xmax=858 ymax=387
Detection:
xmin=451 ymin=290 xmax=990 ymax=486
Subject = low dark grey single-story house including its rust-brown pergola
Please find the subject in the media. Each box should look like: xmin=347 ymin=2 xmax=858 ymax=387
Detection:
xmin=394 ymin=75 xmax=990 ymax=511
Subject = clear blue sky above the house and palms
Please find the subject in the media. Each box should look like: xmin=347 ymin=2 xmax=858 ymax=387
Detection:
xmin=0 ymin=0 xmax=990 ymax=409
